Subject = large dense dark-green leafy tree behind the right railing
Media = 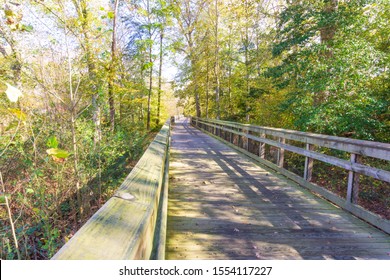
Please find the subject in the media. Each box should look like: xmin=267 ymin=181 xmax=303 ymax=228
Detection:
xmin=269 ymin=0 xmax=384 ymax=139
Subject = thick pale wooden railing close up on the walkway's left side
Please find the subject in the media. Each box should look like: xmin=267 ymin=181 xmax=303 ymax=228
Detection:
xmin=52 ymin=121 xmax=170 ymax=260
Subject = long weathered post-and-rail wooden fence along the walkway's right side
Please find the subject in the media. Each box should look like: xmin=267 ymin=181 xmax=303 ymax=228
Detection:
xmin=191 ymin=117 xmax=390 ymax=233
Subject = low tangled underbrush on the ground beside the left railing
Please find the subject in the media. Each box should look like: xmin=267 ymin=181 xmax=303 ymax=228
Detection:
xmin=0 ymin=115 xmax=158 ymax=259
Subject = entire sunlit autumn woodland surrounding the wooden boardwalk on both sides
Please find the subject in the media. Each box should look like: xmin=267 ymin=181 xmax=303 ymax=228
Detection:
xmin=0 ymin=0 xmax=390 ymax=259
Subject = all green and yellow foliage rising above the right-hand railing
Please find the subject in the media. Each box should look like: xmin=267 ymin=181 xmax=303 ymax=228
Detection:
xmin=175 ymin=0 xmax=390 ymax=142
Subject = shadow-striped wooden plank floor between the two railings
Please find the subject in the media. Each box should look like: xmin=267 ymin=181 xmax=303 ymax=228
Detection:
xmin=166 ymin=119 xmax=390 ymax=259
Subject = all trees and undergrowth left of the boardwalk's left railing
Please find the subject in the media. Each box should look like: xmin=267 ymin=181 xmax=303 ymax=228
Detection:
xmin=0 ymin=0 xmax=169 ymax=259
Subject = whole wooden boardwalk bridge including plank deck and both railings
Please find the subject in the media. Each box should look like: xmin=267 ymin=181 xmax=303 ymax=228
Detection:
xmin=53 ymin=118 xmax=390 ymax=259
